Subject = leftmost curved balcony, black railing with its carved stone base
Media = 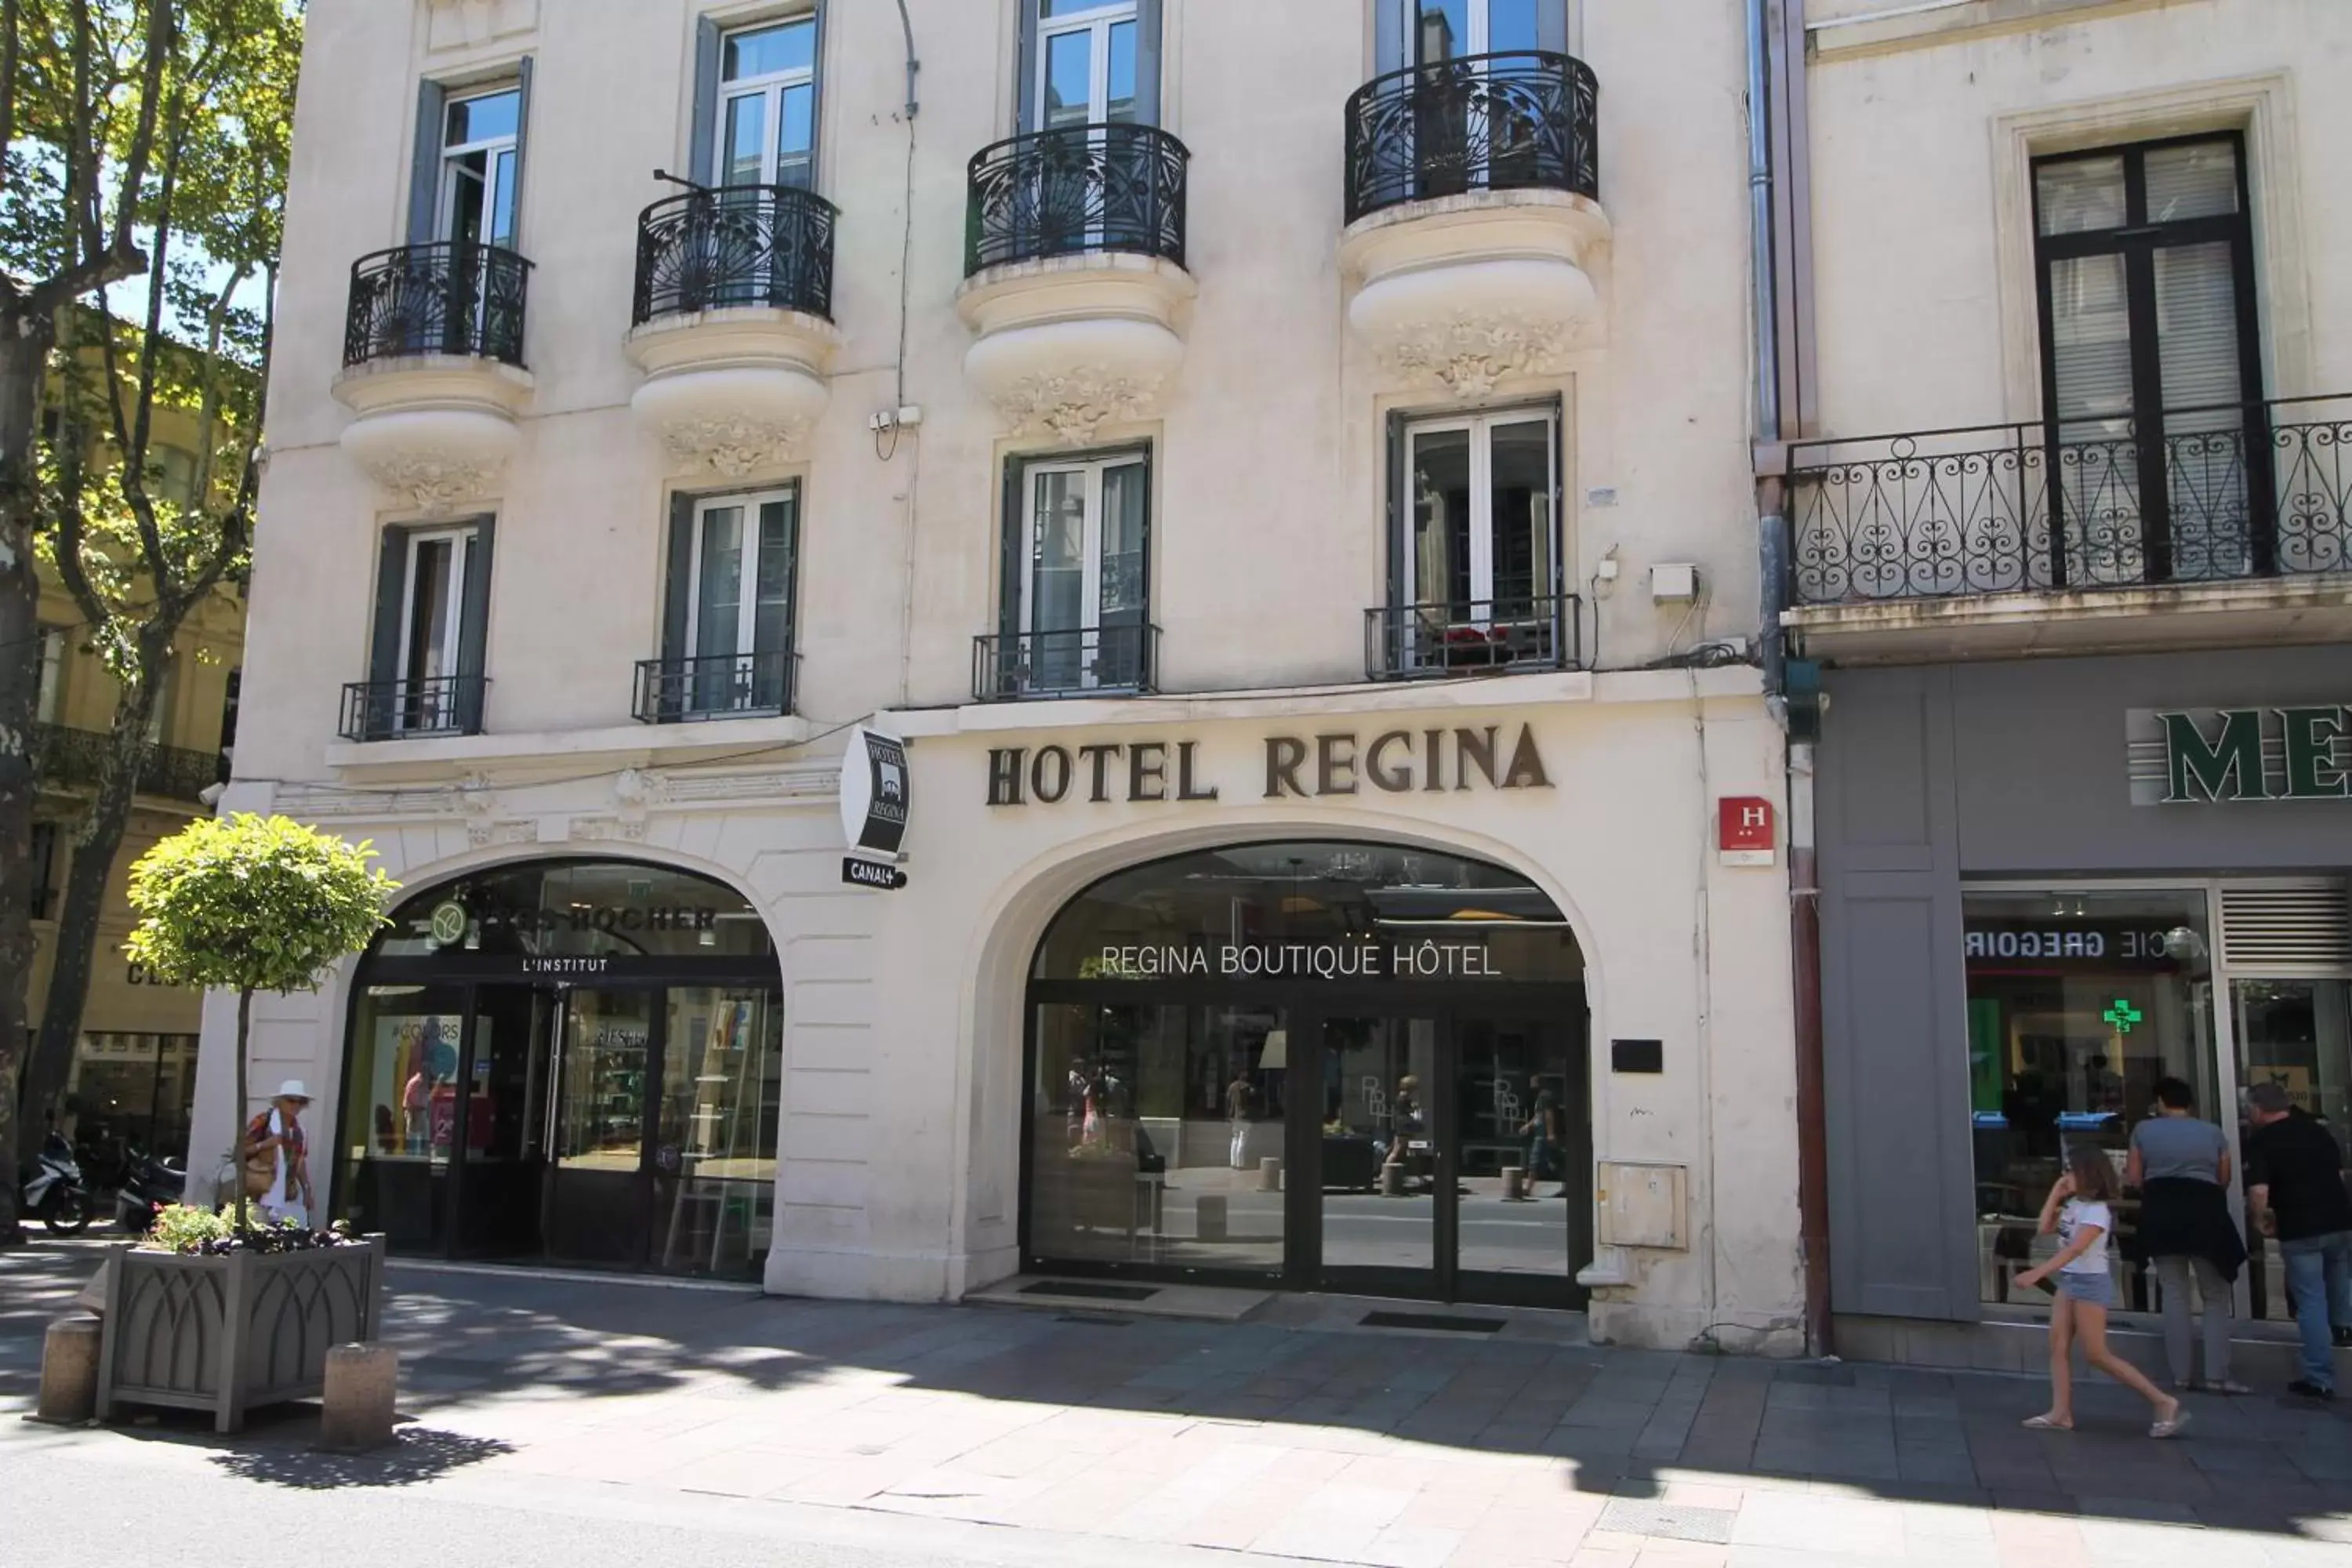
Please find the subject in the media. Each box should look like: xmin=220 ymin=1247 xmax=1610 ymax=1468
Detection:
xmin=334 ymin=242 xmax=532 ymax=517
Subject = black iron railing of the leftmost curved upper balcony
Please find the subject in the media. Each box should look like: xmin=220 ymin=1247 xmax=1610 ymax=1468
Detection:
xmin=343 ymin=240 xmax=532 ymax=365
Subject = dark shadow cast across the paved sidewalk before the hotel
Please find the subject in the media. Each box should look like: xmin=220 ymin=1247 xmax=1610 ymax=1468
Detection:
xmin=0 ymin=1253 xmax=2352 ymax=1540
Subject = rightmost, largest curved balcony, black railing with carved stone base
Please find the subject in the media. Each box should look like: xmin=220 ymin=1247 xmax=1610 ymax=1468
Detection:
xmin=1338 ymin=52 xmax=1609 ymax=400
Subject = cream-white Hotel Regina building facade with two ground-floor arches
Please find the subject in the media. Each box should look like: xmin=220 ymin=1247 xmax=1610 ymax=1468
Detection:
xmin=198 ymin=0 xmax=1802 ymax=1352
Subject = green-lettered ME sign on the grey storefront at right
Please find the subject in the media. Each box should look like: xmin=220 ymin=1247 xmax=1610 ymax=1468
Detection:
xmin=2124 ymin=706 xmax=2352 ymax=806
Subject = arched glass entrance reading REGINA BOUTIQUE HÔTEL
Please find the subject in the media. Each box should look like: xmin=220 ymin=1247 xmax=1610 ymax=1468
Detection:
xmin=1021 ymin=839 xmax=1592 ymax=1307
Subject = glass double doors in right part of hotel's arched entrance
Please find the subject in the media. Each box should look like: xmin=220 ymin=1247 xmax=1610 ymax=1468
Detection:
xmin=1312 ymin=1008 xmax=1592 ymax=1307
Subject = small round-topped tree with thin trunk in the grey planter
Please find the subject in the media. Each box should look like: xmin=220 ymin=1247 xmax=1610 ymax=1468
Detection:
xmin=125 ymin=811 xmax=400 ymax=1232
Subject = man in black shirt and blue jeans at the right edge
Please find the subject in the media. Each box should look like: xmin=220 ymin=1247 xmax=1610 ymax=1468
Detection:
xmin=2246 ymin=1083 xmax=2352 ymax=1399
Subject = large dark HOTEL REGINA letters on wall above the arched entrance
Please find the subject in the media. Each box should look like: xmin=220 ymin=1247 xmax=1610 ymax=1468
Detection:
xmin=988 ymin=724 xmax=1552 ymax=806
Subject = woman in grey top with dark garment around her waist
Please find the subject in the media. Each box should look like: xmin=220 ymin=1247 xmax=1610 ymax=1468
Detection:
xmin=2124 ymin=1079 xmax=2253 ymax=1394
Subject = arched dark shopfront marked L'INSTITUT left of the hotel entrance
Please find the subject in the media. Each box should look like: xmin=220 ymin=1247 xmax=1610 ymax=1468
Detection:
xmin=334 ymin=860 xmax=783 ymax=1276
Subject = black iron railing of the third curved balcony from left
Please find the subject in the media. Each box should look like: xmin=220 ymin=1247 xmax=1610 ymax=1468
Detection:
xmin=964 ymin=125 xmax=1192 ymax=278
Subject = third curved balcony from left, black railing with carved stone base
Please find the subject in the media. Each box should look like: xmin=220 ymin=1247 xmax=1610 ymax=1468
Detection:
xmin=955 ymin=125 xmax=1197 ymax=447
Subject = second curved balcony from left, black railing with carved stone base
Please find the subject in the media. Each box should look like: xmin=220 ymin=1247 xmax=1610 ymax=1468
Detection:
xmin=628 ymin=186 xmax=842 ymax=477
